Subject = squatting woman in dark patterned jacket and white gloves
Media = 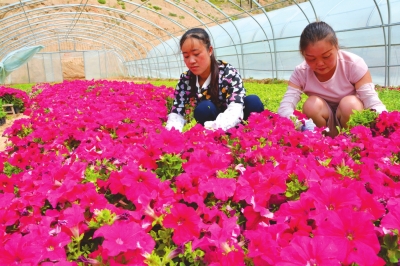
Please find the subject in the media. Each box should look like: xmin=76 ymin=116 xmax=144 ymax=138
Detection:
xmin=166 ymin=28 xmax=264 ymax=131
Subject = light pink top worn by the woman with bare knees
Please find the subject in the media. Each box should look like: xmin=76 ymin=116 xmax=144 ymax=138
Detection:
xmin=290 ymin=50 xmax=368 ymax=103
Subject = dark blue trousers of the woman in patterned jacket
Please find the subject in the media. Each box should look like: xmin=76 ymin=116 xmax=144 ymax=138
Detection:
xmin=194 ymin=95 xmax=264 ymax=126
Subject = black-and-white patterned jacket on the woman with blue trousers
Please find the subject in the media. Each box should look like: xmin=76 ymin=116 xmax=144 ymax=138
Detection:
xmin=171 ymin=60 xmax=246 ymax=116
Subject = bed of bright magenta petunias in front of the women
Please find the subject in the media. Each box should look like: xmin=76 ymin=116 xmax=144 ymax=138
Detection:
xmin=0 ymin=81 xmax=400 ymax=265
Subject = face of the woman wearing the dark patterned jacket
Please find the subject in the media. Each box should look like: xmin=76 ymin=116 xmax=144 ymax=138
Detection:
xmin=181 ymin=37 xmax=213 ymax=79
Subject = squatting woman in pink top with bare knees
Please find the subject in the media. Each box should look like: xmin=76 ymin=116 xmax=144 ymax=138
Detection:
xmin=278 ymin=21 xmax=387 ymax=137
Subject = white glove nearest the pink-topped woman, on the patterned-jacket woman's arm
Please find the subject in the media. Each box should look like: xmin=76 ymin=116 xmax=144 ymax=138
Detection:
xmin=204 ymin=102 xmax=243 ymax=130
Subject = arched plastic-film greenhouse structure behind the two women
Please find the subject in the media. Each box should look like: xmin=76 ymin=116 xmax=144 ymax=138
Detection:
xmin=0 ymin=0 xmax=400 ymax=86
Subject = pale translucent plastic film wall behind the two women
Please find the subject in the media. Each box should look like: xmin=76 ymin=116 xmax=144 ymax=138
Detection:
xmin=140 ymin=0 xmax=400 ymax=85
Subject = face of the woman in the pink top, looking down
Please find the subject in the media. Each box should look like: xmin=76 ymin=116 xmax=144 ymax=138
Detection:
xmin=303 ymin=40 xmax=338 ymax=81
